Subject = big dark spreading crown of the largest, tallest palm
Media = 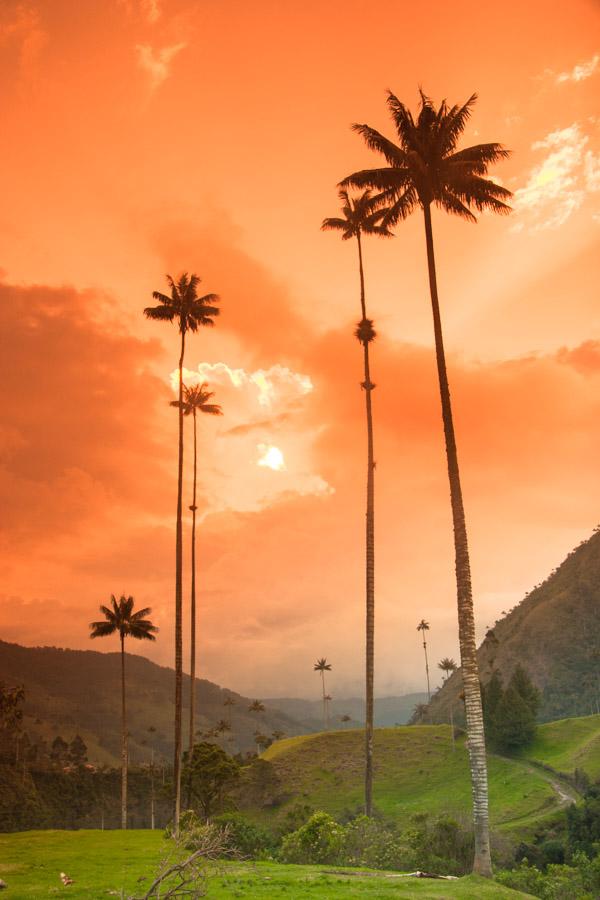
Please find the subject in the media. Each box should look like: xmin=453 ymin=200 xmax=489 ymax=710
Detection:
xmin=340 ymin=91 xmax=512 ymax=228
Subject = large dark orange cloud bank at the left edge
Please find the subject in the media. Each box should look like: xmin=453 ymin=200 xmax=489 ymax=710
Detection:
xmin=0 ymin=284 xmax=168 ymax=546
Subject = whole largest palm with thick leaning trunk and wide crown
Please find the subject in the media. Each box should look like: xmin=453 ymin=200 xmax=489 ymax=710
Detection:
xmin=341 ymin=91 xmax=511 ymax=876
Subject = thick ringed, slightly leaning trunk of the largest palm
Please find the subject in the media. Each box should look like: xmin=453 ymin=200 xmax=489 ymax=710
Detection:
xmin=423 ymin=204 xmax=492 ymax=876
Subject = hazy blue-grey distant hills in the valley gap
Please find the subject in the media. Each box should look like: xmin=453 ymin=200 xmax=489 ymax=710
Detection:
xmin=265 ymin=694 xmax=427 ymax=731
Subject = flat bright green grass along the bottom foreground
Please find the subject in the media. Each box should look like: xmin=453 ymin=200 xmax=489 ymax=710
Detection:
xmin=0 ymin=831 xmax=527 ymax=900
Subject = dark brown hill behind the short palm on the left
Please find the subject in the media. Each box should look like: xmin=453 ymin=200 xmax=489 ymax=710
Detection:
xmin=0 ymin=641 xmax=306 ymax=765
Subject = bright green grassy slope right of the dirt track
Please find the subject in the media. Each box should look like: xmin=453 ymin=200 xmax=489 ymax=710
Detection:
xmin=522 ymin=716 xmax=600 ymax=778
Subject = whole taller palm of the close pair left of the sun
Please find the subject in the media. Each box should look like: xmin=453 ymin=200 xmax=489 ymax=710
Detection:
xmin=144 ymin=272 xmax=219 ymax=833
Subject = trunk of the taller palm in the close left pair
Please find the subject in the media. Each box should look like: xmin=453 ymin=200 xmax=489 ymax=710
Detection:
xmin=173 ymin=331 xmax=185 ymax=835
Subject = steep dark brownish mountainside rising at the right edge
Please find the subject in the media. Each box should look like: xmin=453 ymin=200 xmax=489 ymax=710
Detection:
xmin=427 ymin=530 xmax=600 ymax=722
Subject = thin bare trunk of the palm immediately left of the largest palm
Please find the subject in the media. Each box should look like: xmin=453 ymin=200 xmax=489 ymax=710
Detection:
xmin=356 ymin=231 xmax=375 ymax=816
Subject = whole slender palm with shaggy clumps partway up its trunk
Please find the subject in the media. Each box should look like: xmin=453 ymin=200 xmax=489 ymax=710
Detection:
xmin=321 ymin=189 xmax=392 ymax=816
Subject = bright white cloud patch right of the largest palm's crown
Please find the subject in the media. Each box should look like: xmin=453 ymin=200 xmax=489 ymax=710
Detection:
xmin=512 ymin=122 xmax=600 ymax=231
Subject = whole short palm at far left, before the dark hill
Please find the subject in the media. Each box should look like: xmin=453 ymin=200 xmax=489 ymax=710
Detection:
xmin=90 ymin=594 xmax=158 ymax=828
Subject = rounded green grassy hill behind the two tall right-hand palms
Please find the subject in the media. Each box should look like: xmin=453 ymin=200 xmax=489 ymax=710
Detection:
xmin=240 ymin=717 xmax=584 ymax=830
